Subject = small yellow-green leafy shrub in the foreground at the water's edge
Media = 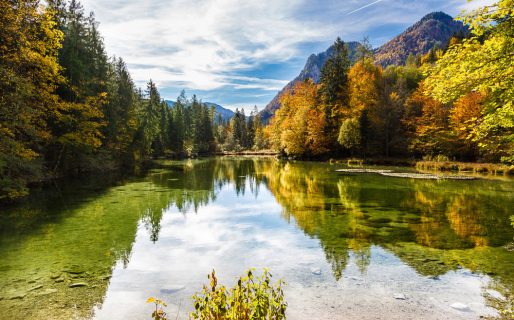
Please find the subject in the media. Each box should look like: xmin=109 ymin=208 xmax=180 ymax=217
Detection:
xmin=190 ymin=269 xmax=287 ymax=320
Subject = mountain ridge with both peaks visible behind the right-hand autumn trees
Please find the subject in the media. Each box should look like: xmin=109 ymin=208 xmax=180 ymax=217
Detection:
xmin=261 ymin=12 xmax=468 ymax=122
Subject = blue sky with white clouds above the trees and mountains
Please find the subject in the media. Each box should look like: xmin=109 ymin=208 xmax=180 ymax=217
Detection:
xmin=82 ymin=0 xmax=494 ymax=110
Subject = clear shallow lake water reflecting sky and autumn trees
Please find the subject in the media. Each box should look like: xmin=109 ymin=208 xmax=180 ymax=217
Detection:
xmin=0 ymin=158 xmax=514 ymax=319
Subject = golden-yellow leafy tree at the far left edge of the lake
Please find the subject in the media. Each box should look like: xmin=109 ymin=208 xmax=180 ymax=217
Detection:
xmin=0 ymin=0 xmax=62 ymax=200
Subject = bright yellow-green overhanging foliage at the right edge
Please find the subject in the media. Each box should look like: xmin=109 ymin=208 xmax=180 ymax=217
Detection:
xmin=426 ymin=0 xmax=514 ymax=162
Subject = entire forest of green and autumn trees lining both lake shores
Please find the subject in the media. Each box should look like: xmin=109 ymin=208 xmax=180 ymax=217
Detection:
xmin=0 ymin=0 xmax=514 ymax=201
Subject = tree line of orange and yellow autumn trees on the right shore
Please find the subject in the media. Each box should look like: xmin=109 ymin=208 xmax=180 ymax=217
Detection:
xmin=268 ymin=0 xmax=514 ymax=163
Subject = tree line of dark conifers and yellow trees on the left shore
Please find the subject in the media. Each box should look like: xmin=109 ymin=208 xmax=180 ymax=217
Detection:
xmin=0 ymin=0 xmax=262 ymax=201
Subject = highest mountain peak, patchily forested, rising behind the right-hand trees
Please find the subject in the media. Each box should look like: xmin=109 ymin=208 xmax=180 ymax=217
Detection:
xmin=375 ymin=12 xmax=468 ymax=67
